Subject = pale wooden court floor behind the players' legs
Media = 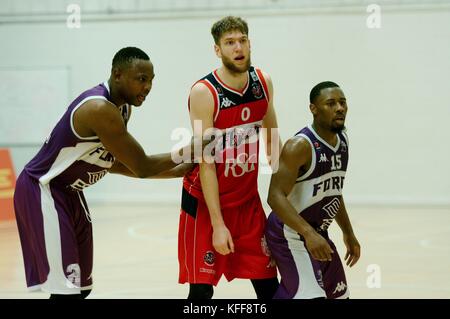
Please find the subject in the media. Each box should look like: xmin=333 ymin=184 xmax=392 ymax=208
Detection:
xmin=0 ymin=205 xmax=450 ymax=299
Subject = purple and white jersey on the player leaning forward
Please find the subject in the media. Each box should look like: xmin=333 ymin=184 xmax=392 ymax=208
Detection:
xmin=24 ymin=82 xmax=130 ymax=190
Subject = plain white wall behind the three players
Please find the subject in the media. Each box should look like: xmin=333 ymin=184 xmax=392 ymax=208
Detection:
xmin=0 ymin=10 xmax=450 ymax=205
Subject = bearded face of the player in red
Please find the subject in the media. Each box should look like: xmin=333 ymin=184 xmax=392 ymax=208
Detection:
xmin=214 ymin=31 xmax=251 ymax=73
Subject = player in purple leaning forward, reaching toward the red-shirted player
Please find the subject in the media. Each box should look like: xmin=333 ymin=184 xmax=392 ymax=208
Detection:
xmin=14 ymin=47 xmax=192 ymax=299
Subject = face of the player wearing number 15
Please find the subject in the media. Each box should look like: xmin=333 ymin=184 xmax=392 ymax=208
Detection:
xmin=311 ymin=87 xmax=347 ymax=133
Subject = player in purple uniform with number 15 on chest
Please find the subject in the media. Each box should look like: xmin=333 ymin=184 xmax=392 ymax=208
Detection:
xmin=266 ymin=82 xmax=360 ymax=299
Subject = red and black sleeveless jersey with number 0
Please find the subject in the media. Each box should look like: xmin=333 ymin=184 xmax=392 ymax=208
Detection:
xmin=183 ymin=67 xmax=269 ymax=208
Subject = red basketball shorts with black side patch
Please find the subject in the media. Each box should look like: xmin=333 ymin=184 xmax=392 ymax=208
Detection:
xmin=178 ymin=189 xmax=277 ymax=285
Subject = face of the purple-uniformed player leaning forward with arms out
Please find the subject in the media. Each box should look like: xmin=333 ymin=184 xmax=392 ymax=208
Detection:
xmin=121 ymin=59 xmax=155 ymax=106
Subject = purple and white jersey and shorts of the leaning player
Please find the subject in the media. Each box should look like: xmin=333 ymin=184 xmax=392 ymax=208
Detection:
xmin=14 ymin=82 xmax=130 ymax=294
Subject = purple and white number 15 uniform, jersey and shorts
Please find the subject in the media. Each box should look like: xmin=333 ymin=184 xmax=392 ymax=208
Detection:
xmin=266 ymin=126 xmax=349 ymax=299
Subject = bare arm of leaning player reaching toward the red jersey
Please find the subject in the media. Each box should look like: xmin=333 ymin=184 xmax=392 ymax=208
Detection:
xmin=74 ymin=100 xmax=186 ymax=178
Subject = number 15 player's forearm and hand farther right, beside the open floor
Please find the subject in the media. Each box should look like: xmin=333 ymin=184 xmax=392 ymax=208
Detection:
xmin=334 ymin=197 xmax=361 ymax=267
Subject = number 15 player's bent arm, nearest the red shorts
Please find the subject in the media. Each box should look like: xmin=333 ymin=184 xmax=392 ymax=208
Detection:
xmin=267 ymin=137 xmax=333 ymax=261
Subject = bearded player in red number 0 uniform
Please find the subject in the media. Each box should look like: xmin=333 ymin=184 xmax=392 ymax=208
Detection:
xmin=178 ymin=16 xmax=280 ymax=299
